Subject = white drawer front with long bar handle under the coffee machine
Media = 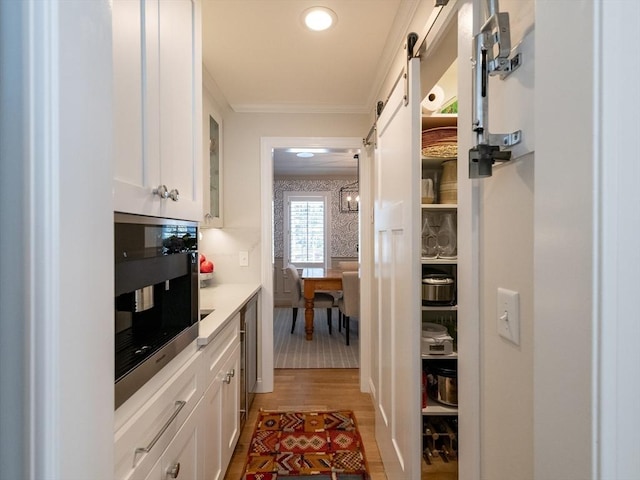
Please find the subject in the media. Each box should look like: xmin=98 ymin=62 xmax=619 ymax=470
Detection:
xmin=115 ymin=352 xmax=204 ymax=479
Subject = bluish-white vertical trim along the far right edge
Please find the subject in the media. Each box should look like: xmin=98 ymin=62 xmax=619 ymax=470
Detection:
xmin=592 ymin=2 xmax=640 ymax=479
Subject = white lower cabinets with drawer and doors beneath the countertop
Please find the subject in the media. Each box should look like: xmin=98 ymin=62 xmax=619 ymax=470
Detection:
xmin=114 ymin=314 xmax=240 ymax=480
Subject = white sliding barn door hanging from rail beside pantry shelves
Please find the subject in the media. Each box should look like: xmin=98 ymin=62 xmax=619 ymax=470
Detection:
xmin=372 ymin=59 xmax=421 ymax=479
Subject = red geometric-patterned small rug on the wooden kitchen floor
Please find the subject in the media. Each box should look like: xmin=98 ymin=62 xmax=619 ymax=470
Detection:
xmin=242 ymin=410 xmax=369 ymax=480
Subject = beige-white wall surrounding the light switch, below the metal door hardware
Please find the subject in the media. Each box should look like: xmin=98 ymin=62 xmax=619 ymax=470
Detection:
xmin=474 ymin=0 xmax=537 ymax=480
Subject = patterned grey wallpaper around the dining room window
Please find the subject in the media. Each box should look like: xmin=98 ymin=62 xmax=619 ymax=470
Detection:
xmin=273 ymin=178 xmax=358 ymax=258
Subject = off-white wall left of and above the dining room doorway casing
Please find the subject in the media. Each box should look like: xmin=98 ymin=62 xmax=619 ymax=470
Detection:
xmin=200 ymin=112 xmax=370 ymax=283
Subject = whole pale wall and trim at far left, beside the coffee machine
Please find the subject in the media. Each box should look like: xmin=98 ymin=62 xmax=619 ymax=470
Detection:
xmin=0 ymin=0 xmax=114 ymax=480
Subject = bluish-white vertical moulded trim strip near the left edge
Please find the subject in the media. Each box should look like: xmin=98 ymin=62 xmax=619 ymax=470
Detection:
xmin=25 ymin=2 xmax=63 ymax=472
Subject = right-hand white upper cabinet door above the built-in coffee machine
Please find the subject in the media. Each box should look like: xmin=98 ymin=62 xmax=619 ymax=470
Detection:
xmin=158 ymin=0 xmax=202 ymax=221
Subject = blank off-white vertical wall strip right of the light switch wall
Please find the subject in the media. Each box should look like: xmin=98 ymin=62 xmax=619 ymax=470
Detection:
xmin=533 ymin=0 xmax=592 ymax=480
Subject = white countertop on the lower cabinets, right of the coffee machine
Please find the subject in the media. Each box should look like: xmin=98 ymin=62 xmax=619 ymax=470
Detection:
xmin=198 ymin=283 xmax=261 ymax=345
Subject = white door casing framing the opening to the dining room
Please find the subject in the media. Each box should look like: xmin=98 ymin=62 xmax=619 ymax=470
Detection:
xmin=258 ymin=137 xmax=371 ymax=392
